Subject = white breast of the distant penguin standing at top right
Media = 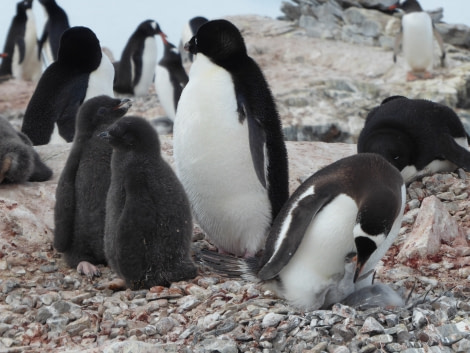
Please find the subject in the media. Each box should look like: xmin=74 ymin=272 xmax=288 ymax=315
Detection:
xmin=402 ymin=12 xmax=434 ymax=71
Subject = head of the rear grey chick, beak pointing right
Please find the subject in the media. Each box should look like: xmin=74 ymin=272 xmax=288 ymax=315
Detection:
xmin=77 ymin=95 xmax=132 ymax=131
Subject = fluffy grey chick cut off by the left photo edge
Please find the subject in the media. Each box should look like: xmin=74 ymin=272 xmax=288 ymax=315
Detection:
xmin=0 ymin=116 xmax=52 ymax=183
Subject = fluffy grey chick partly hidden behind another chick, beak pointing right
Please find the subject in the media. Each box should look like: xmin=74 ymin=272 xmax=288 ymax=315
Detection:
xmin=54 ymin=96 xmax=131 ymax=277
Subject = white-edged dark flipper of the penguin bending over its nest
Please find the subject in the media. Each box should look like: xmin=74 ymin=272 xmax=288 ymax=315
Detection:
xmin=257 ymin=192 xmax=332 ymax=281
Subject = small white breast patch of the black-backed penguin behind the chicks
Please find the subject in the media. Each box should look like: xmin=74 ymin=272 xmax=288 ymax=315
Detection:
xmin=85 ymin=52 xmax=114 ymax=101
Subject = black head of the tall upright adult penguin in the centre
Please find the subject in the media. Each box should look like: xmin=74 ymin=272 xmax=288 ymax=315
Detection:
xmin=184 ymin=20 xmax=247 ymax=67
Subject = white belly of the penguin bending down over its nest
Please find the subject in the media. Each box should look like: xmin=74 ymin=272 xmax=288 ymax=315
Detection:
xmin=279 ymin=194 xmax=358 ymax=310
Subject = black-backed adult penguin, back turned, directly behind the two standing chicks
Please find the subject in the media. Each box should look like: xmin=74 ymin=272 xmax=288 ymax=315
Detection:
xmin=21 ymin=27 xmax=114 ymax=145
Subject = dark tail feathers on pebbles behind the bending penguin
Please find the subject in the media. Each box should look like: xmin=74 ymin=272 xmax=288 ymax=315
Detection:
xmin=199 ymin=249 xmax=259 ymax=282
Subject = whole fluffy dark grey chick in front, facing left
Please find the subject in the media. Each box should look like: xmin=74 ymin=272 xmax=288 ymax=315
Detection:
xmin=100 ymin=117 xmax=197 ymax=289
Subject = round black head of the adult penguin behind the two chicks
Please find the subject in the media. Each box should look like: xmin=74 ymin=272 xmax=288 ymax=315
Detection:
xmin=57 ymin=27 xmax=102 ymax=72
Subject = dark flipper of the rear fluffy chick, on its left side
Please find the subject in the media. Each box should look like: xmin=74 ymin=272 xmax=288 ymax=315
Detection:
xmin=53 ymin=148 xmax=81 ymax=252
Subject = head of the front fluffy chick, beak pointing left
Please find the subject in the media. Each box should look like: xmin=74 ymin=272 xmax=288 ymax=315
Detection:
xmin=100 ymin=116 xmax=160 ymax=151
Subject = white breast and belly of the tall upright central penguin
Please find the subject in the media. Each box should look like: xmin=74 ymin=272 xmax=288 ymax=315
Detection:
xmin=174 ymin=54 xmax=271 ymax=255
